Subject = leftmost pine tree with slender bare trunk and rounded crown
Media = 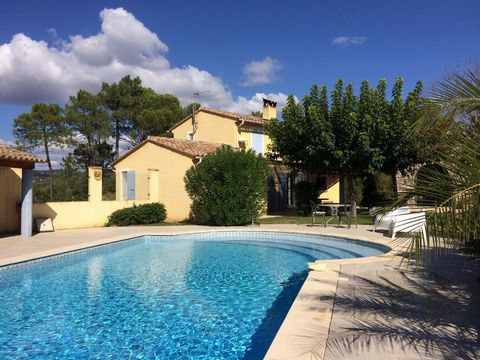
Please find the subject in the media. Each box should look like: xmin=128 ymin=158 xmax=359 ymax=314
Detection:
xmin=13 ymin=103 xmax=69 ymax=200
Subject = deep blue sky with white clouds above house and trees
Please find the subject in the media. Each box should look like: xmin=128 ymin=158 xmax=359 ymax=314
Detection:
xmin=0 ymin=0 xmax=480 ymax=160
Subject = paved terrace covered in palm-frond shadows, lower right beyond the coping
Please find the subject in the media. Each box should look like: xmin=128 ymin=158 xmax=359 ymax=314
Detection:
xmin=325 ymin=254 xmax=480 ymax=359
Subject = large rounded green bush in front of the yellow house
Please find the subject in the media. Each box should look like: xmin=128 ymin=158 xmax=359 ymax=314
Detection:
xmin=185 ymin=146 xmax=271 ymax=226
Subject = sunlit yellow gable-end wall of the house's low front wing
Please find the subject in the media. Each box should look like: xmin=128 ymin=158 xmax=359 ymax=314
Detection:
xmin=115 ymin=142 xmax=193 ymax=221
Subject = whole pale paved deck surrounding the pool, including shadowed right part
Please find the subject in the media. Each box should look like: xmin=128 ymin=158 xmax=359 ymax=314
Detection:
xmin=0 ymin=224 xmax=480 ymax=360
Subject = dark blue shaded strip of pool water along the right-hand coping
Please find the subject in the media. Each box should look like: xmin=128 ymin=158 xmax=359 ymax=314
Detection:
xmin=243 ymin=271 xmax=308 ymax=360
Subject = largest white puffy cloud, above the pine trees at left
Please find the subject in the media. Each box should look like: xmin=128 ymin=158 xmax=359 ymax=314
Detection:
xmin=0 ymin=8 xmax=286 ymax=109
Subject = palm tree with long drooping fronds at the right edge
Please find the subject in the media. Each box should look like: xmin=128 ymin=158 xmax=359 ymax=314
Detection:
xmin=398 ymin=69 xmax=480 ymax=263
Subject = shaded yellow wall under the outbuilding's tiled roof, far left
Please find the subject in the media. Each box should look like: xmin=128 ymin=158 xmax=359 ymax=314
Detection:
xmin=0 ymin=167 xmax=22 ymax=234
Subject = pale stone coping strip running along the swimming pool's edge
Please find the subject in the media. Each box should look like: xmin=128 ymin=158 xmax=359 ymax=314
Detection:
xmin=0 ymin=226 xmax=400 ymax=360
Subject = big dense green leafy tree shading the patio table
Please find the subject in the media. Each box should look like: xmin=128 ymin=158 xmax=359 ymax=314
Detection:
xmin=265 ymin=78 xmax=428 ymax=204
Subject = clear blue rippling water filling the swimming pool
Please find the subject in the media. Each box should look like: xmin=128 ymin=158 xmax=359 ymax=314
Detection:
xmin=0 ymin=232 xmax=387 ymax=359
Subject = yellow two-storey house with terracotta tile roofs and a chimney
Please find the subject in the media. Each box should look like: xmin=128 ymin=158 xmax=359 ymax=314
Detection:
xmin=112 ymin=99 xmax=339 ymax=220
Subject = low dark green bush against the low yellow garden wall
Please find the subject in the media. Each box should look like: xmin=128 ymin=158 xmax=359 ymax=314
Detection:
xmin=107 ymin=203 xmax=167 ymax=226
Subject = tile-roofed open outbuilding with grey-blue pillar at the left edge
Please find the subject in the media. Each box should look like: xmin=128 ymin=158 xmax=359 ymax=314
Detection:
xmin=0 ymin=144 xmax=45 ymax=237
